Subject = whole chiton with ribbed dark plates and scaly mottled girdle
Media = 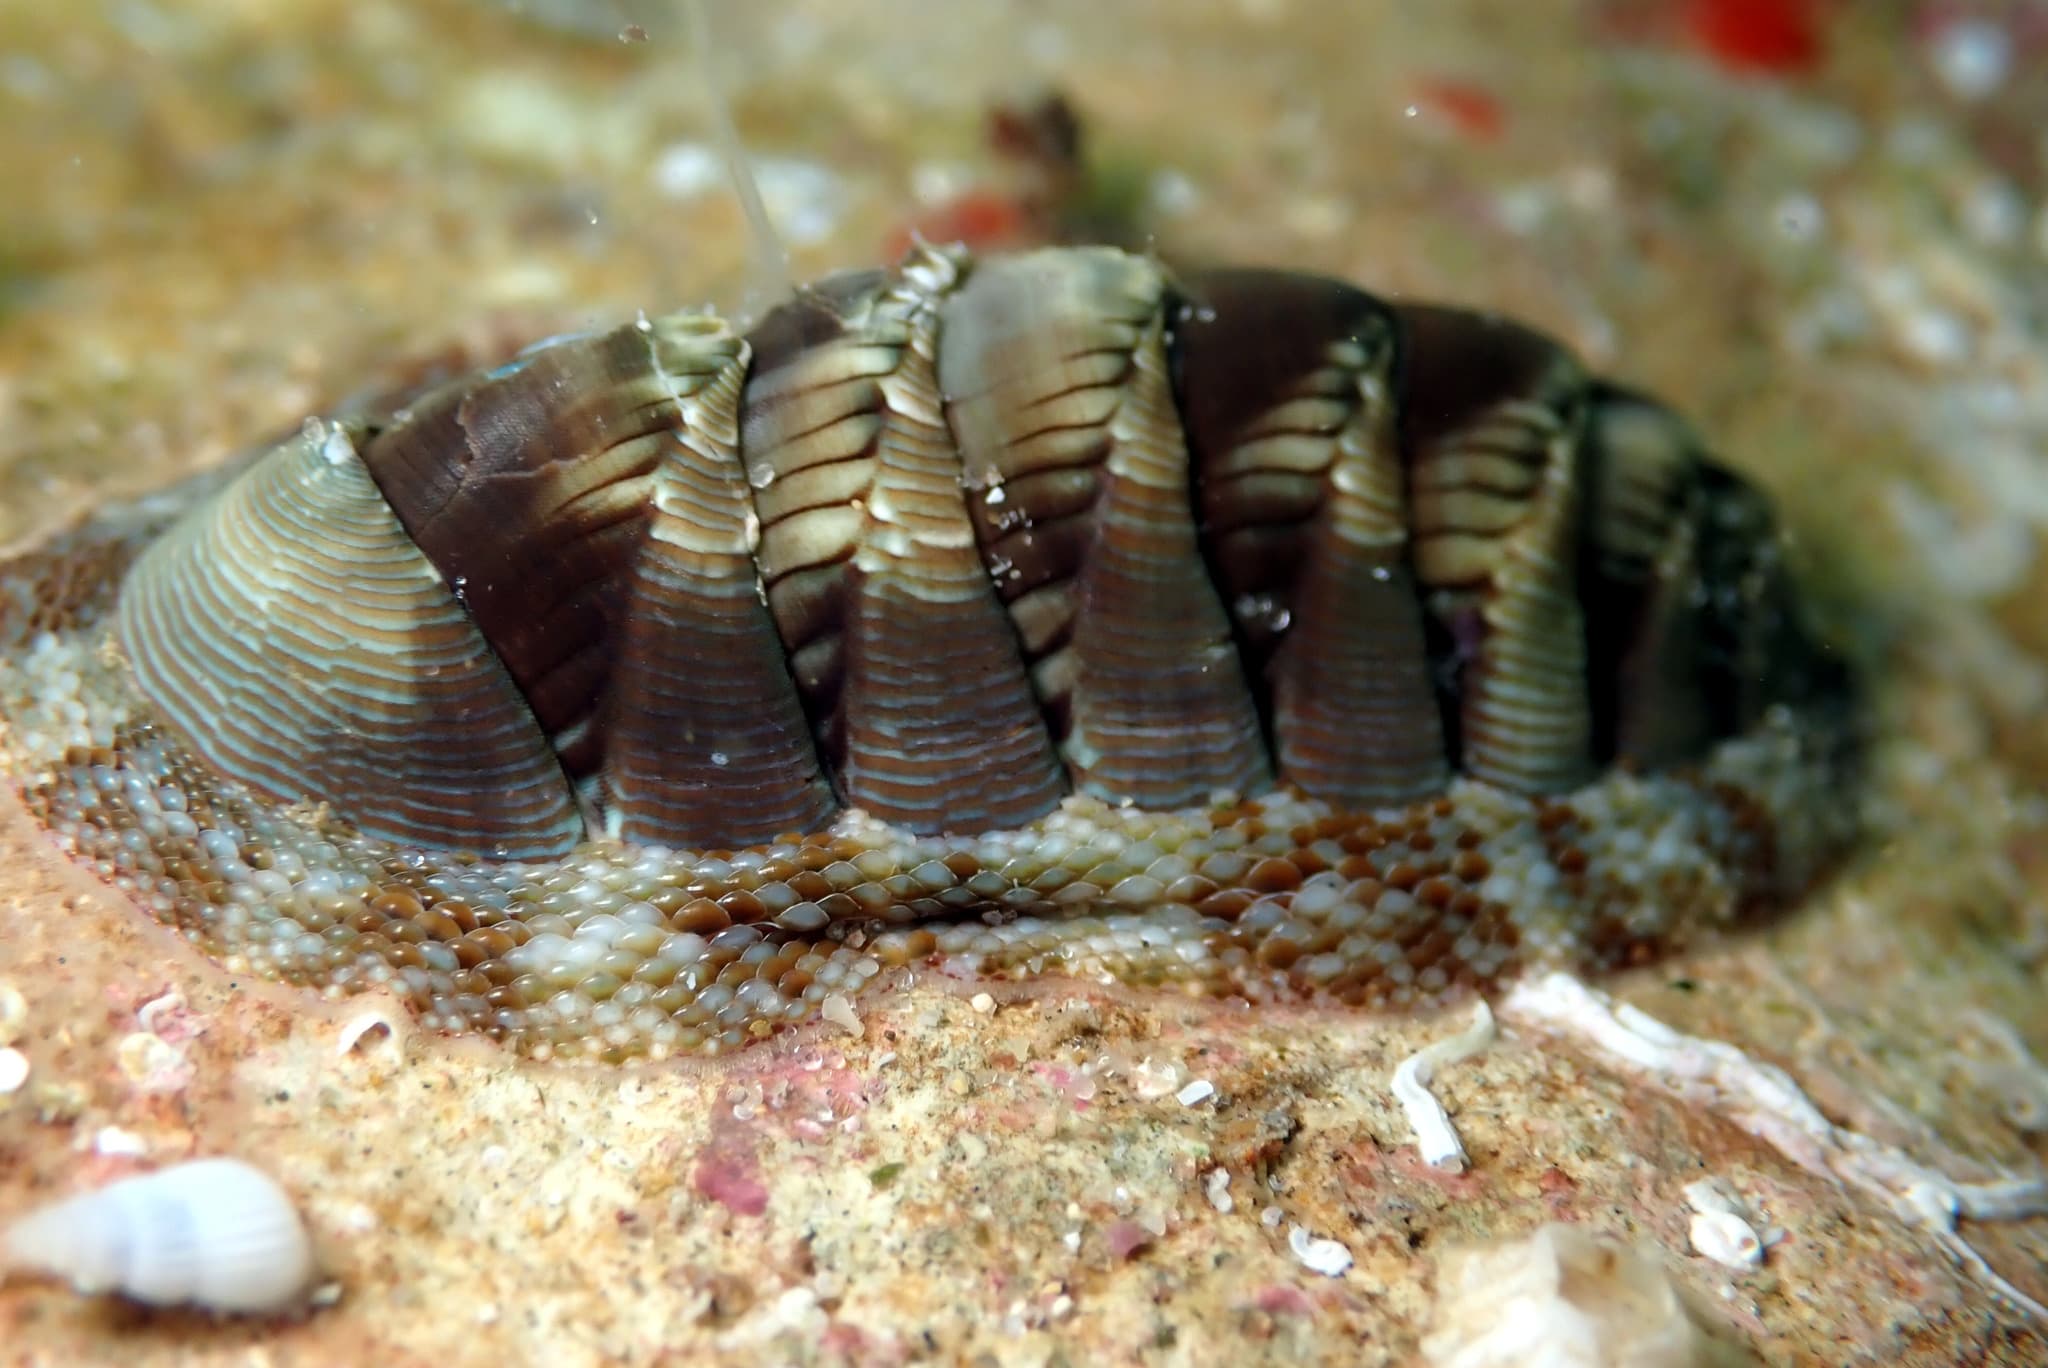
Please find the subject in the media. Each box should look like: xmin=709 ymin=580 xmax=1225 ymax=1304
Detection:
xmin=0 ymin=246 xmax=1853 ymax=1059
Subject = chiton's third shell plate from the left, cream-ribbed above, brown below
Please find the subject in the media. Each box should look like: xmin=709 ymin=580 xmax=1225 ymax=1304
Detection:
xmin=743 ymin=248 xmax=1065 ymax=831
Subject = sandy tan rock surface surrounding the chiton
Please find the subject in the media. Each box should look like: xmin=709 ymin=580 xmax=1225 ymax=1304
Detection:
xmin=0 ymin=0 xmax=2048 ymax=1368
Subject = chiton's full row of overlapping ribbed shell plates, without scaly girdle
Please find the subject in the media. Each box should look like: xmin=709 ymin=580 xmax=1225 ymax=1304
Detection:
xmin=99 ymin=246 xmax=1843 ymax=854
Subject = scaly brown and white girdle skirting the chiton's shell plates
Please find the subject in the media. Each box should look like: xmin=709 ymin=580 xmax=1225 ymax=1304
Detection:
xmin=0 ymin=498 xmax=1851 ymax=1059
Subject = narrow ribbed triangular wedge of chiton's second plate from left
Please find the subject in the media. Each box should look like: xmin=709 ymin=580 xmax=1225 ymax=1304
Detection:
xmin=604 ymin=319 xmax=834 ymax=846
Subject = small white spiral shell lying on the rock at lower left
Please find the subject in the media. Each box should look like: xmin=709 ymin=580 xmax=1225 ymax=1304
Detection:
xmin=0 ymin=1159 xmax=315 ymax=1315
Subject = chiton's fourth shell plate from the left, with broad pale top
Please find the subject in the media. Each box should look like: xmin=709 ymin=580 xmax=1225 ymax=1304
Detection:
xmin=938 ymin=248 xmax=1270 ymax=807
